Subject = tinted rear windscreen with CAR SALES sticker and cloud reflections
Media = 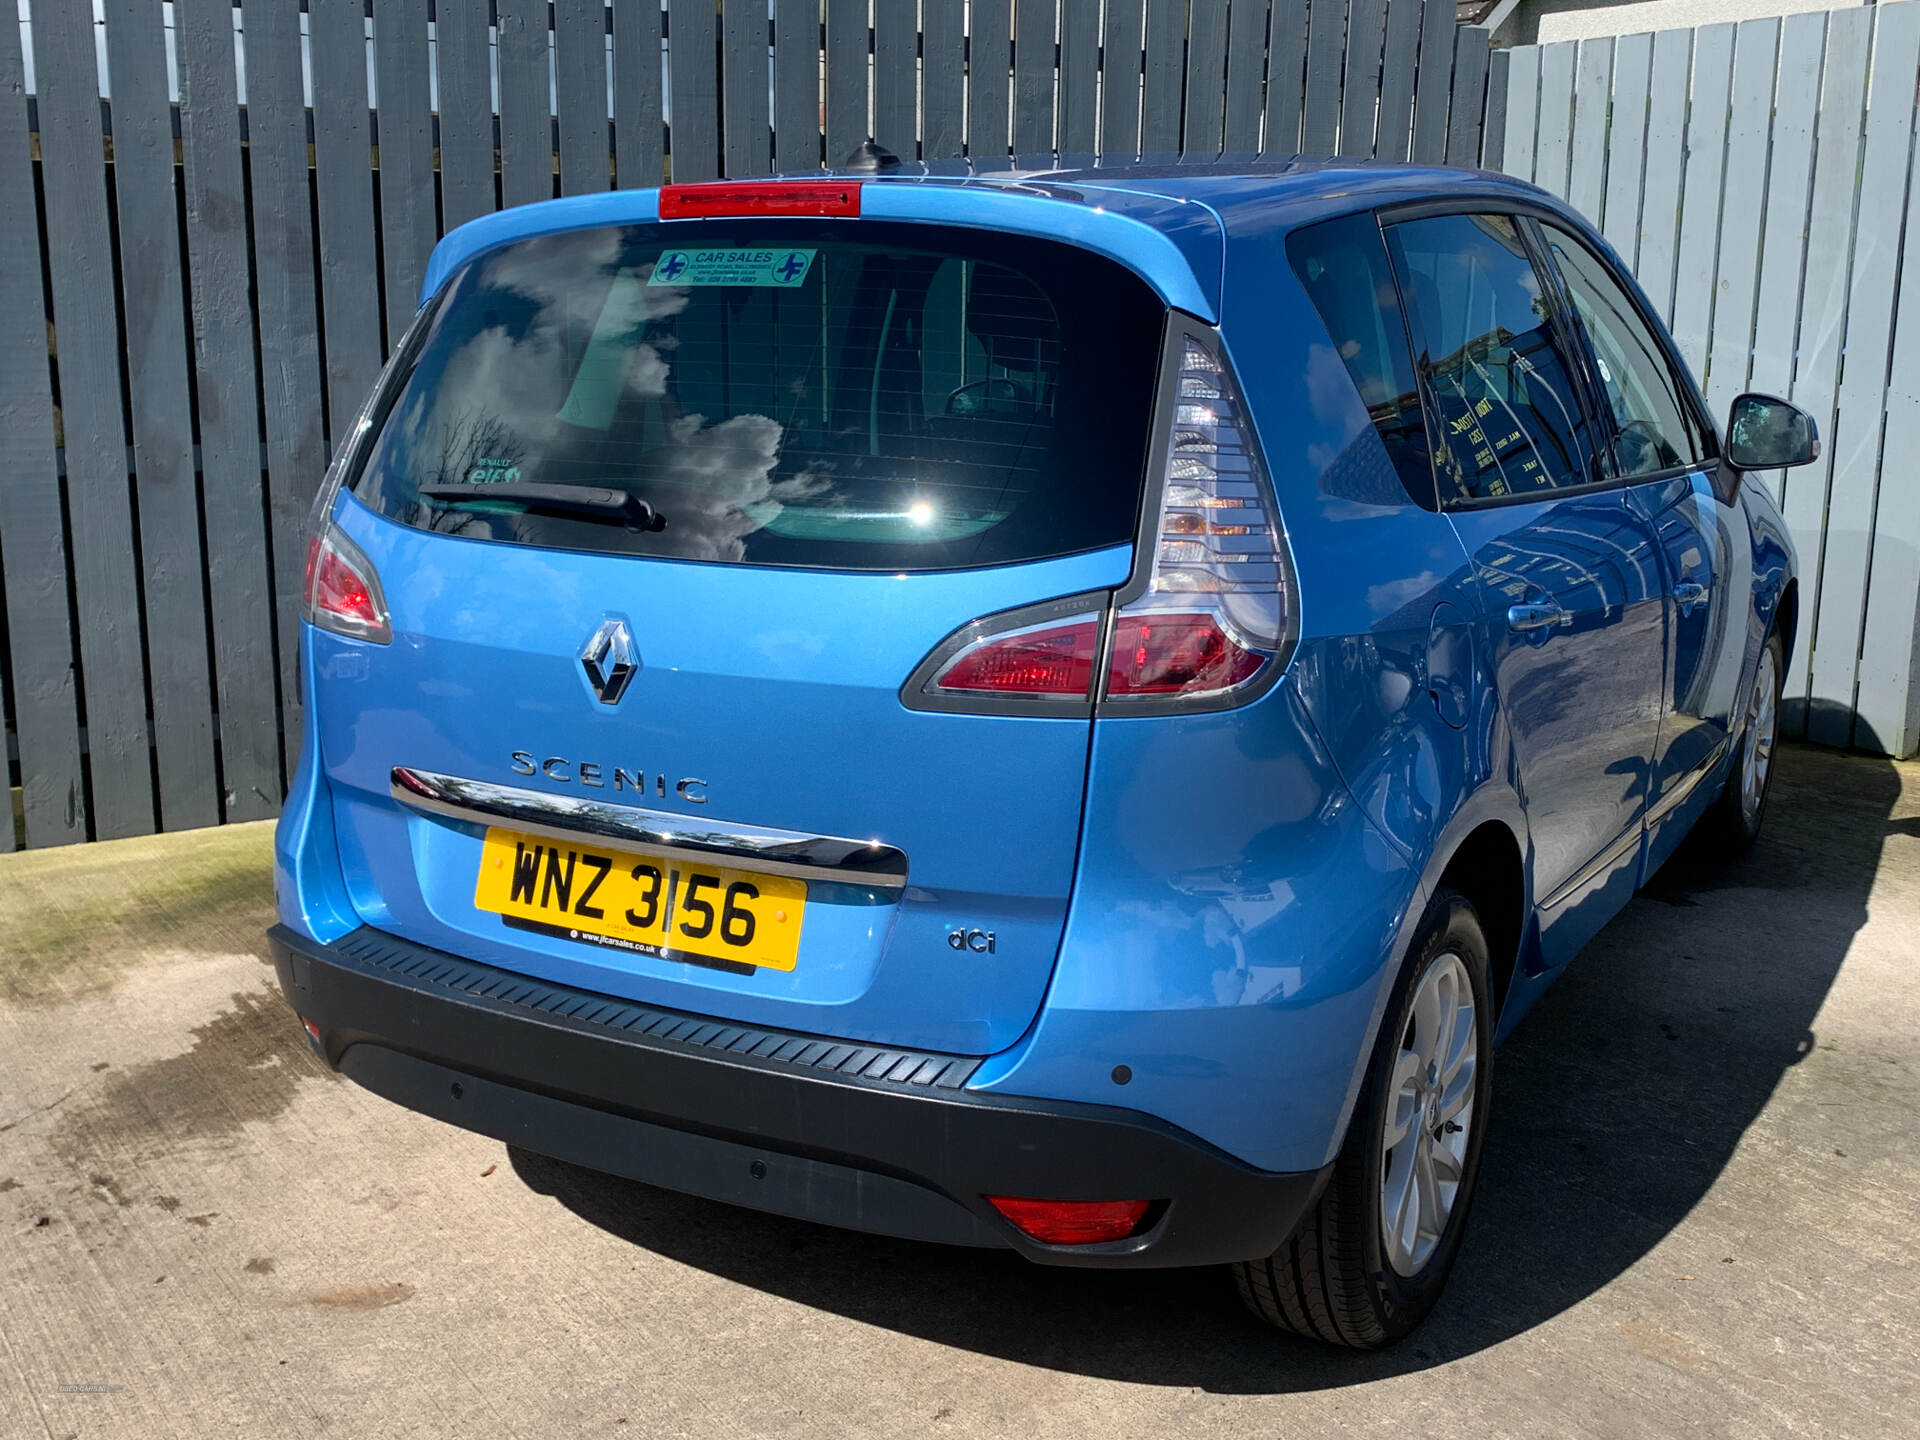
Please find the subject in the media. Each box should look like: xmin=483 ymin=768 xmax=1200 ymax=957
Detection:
xmin=355 ymin=221 xmax=1164 ymax=570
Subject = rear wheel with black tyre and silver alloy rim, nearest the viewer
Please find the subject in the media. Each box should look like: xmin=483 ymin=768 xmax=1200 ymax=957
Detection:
xmin=1233 ymin=889 xmax=1494 ymax=1350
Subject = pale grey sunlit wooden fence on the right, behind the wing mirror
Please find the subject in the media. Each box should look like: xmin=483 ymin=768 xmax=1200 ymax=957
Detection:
xmin=1488 ymin=4 xmax=1920 ymax=755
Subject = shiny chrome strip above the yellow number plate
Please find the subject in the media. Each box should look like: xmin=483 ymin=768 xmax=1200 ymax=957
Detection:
xmin=390 ymin=766 xmax=906 ymax=893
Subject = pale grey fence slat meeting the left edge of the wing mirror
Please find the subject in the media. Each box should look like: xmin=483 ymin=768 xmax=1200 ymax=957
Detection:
xmin=1705 ymin=19 xmax=1780 ymax=417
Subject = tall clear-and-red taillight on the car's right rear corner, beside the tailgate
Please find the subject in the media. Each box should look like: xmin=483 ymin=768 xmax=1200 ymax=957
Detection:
xmin=1106 ymin=332 xmax=1294 ymax=703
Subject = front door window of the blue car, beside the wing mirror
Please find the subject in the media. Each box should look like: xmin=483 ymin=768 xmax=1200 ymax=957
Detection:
xmin=1540 ymin=225 xmax=1707 ymax=480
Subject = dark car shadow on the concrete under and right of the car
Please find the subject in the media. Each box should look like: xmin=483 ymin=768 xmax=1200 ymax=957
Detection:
xmin=511 ymin=749 xmax=1912 ymax=1394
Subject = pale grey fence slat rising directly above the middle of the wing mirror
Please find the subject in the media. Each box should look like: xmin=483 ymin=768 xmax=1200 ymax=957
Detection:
xmin=1749 ymin=12 xmax=1826 ymax=501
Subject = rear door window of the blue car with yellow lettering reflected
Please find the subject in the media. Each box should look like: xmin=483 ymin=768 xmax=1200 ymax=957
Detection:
xmin=1386 ymin=215 xmax=1601 ymax=503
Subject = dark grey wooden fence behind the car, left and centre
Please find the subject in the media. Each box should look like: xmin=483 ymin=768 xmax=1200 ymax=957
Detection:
xmin=0 ymin=0 xmax=1488 ymax=849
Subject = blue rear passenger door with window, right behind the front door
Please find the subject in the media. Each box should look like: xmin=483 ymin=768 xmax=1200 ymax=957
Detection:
xmin=1386 ymin=211 xmax=1663 ymax=964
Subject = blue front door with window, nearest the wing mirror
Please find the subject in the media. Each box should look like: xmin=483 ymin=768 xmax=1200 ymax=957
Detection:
xmin=1540 ymin=223 xmax=1753 ymax=874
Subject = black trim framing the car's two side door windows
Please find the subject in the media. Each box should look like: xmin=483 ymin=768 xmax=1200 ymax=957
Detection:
xmin=1373 ymin=196 xmax=1720 ymax=515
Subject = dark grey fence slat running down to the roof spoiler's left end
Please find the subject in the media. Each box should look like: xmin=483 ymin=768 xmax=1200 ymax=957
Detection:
xmin=372 ymin=0 xmax=440 ymax=339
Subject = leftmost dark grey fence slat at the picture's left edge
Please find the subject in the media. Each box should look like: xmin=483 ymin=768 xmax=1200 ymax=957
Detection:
xmin=0 ymin=8 xmax=86 ymax=851
